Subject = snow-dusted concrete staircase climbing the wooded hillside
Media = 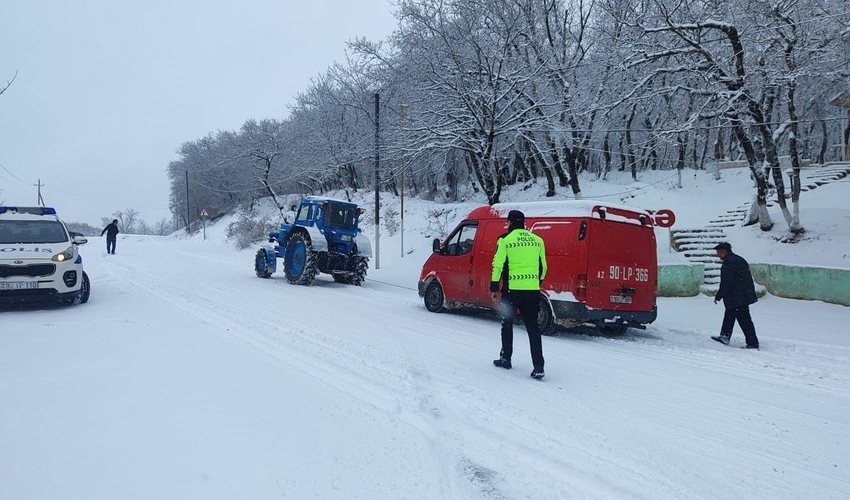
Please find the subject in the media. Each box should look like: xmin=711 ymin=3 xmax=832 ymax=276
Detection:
xmin=670 ymin=163 xmax=850 ymax=295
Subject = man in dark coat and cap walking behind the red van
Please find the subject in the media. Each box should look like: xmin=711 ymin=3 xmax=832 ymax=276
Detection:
xmin=711 ymin=242 xmax=759 ymax=349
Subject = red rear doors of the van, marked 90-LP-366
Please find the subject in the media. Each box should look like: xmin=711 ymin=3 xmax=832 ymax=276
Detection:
xmin=586 ymin=207 xmax=658 ymax=311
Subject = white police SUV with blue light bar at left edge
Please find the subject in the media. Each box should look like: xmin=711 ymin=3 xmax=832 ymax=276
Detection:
xmin=0 ymin=206 xmax=90 ymax=306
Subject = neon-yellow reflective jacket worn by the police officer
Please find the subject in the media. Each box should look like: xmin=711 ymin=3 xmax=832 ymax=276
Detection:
xmin=490 ymin=229 xmax=546 ymax=292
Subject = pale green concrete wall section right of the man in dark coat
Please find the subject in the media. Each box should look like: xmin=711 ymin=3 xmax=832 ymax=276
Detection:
xmin=750 ymin=264 xmax=850 ymax=306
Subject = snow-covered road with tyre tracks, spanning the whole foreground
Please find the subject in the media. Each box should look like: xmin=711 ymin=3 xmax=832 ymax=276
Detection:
xmin=0 ymin=237 xmax=850 ymax=499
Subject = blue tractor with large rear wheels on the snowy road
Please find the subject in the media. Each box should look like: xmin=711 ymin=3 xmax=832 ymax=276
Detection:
xmin=254 ymin=196 xmax=372 ymax=286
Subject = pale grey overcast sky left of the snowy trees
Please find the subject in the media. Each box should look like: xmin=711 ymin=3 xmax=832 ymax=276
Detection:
xmin=0 ymin=0 xmax=396 ymax=225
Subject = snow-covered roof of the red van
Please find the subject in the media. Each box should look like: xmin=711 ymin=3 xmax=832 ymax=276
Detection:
xmin=467 ymin=200 xmax=652 ymax=225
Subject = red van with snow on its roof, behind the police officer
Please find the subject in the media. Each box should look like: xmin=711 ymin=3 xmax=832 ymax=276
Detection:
xmin=419 ymin=200 xmax=658 ymax=334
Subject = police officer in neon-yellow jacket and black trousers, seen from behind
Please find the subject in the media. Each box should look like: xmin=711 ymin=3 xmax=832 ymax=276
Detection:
xmin=490 ymin=210 xmax=546 ymax=379
